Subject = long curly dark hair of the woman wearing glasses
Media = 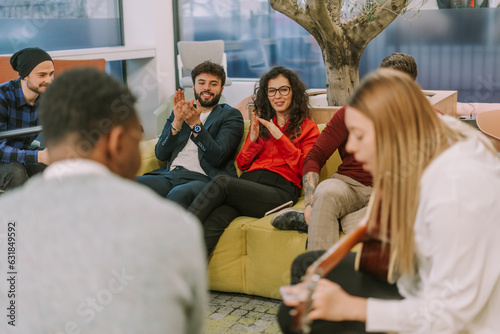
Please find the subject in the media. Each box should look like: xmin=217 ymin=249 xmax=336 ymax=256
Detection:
xmin=254 ymin=66 xmax=310 ymax=139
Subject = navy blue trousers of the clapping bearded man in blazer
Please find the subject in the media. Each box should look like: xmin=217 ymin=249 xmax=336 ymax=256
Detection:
xmin=136 ymin=167 xmax=210 ymax=208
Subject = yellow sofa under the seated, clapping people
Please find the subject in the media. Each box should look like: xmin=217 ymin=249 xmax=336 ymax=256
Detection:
xmin=138 ymin=121 xmax=341 ymax=299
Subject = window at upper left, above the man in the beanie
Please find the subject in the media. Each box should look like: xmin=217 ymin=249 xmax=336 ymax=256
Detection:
xmin=0 ymin=0 xmax=122 ymax=54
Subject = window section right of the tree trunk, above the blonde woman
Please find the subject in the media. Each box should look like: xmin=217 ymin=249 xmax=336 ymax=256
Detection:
xmin=359 ymin=6 xmax=500 ymax=103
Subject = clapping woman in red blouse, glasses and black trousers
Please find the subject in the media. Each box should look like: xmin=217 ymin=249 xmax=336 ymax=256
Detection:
xmin=189 ymin=67 xmax=319 ymax=255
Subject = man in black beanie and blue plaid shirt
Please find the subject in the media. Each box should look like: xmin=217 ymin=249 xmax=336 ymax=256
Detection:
xmin=0 ymin=48 xmax=54 ymax=192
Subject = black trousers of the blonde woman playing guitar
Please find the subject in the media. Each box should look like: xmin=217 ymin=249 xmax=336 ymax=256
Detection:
xmin=278 ymin=251 xmax=402 ymax=334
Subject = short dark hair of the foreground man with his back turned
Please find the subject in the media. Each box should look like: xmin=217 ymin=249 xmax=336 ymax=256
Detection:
xmin=39 ymin=68 xmax=138 ymax=147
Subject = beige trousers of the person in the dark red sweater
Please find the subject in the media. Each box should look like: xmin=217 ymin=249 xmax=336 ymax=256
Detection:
xmin=307 ymin=173 xmax=372 ymax=250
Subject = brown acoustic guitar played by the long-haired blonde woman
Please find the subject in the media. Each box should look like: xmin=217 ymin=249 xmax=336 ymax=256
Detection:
xmin=291 ymin=219 xmax=396 ymax=333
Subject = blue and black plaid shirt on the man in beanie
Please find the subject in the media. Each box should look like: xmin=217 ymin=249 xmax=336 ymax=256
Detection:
xmin=0 ymin=78 xmax=39 ymax=164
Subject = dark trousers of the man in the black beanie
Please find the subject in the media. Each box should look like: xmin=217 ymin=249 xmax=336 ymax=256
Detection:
xmin=0 ymin=162 xmax=47 ymax=190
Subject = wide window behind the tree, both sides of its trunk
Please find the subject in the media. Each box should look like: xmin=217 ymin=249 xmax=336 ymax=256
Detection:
xmin=177 ymin=0 xmax=500 ymax=102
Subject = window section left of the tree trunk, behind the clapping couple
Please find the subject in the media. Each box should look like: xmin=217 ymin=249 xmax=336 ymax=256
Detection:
xmin=179 ymin=0 xmax=326 ymax=87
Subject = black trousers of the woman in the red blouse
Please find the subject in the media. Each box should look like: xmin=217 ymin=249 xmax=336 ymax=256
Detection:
xmin=189 ymin=170 xmax=300 ymax=255
